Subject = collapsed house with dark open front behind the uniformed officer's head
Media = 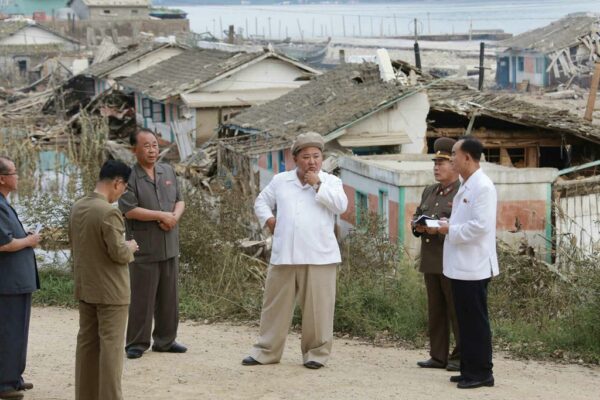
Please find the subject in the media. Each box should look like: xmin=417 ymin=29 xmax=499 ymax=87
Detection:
xmin=427 ymin=81 xmax=600 ymax=169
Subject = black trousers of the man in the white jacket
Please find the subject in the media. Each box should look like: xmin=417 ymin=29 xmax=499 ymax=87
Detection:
xmin=452 ymin=278 xmax=494 ymax=381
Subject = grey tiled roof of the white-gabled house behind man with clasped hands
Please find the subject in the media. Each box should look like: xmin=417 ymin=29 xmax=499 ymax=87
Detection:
xmin=121 ymin=49 xmax=272 ymax=100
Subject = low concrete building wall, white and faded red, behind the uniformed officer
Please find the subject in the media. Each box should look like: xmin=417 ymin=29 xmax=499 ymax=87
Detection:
xmin=339 ymin=157 xmax=557 ymax=257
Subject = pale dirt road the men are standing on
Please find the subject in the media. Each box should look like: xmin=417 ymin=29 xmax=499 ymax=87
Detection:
xmin=25 ymin=308 xmax=600 ymax=400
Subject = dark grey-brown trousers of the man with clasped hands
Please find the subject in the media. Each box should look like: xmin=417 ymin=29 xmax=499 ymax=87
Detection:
xmin=125 ymin=257 xmax=179 ymax=351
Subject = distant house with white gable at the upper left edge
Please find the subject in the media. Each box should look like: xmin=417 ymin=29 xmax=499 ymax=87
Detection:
xmin=0 ymin=21 xmax=79 ymax=83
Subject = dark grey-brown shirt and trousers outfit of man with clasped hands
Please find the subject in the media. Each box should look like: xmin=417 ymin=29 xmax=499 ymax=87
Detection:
xmin=119 ymin=163 xmax=183 ymax=351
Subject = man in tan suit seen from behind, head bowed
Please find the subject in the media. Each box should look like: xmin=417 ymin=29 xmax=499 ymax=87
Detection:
xmin=69 ymin=161 xmax=138 ymax=400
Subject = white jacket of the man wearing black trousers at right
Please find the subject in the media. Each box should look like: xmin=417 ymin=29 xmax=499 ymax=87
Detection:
xmin=444 ymin=168 xmax=499 ymax=281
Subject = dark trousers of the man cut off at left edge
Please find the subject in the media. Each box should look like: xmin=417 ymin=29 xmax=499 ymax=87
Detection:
xmin=0 ymin=293 xmax=31 ymax=392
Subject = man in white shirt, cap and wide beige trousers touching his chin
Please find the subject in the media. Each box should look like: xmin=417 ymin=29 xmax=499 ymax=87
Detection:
xmin=242 ymin=132 xmax=348 ymax=369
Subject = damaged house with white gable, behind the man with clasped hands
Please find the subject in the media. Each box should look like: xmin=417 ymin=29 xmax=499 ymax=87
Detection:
xmin=121 ymin=49 xmax=319 ymax=144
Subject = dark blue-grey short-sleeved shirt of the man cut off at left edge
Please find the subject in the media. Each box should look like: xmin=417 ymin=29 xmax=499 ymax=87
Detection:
xmin=0 ymin=193 xmax=40 ymax=295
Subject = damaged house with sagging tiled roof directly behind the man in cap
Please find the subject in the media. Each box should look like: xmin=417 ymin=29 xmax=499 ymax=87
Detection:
xmin=219 ymin=57 xmax=429 ymax=191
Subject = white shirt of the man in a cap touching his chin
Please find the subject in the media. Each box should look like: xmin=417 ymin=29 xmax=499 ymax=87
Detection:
xmin=254 ymin=170 xmax=348 ymax=265
